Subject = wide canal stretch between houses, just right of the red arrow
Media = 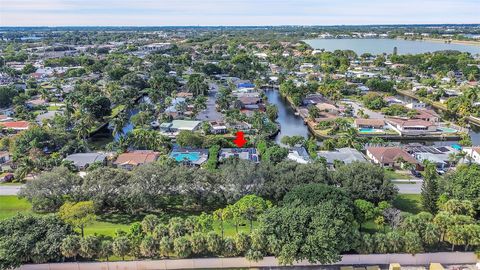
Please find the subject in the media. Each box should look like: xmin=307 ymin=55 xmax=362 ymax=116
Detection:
xmin=265 ymin=90 xmax=310 ymax=143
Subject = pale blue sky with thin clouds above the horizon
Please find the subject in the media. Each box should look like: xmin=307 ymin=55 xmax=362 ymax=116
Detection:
xmin=0 ymin=0 xmax=480 ymax=26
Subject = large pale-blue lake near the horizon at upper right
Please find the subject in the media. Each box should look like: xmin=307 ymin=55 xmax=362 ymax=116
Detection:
xmin=305 ymin=39 xmax=480 ymax=55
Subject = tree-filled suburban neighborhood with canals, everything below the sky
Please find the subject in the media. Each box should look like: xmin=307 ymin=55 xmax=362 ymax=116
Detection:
xmin=0 ymin=0 xmax=480 ymax=270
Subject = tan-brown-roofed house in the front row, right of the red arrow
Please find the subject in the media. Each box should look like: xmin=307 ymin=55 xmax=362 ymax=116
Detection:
xmin=366 ymin=147 xmax=418 ymax=168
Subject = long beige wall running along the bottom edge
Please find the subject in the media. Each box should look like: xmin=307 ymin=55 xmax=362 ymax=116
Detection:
xmin=17 ymin=252 xmax=477 ymax=270
